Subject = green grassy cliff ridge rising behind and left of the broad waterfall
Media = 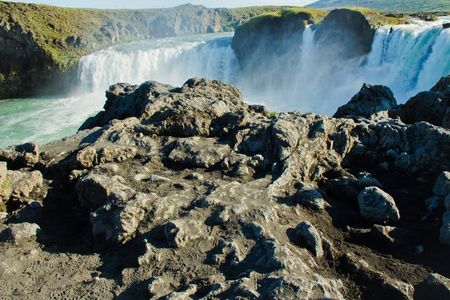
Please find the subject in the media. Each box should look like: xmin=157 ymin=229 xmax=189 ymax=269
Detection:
xmin=0 ymin=1 xmax=294 ymax=99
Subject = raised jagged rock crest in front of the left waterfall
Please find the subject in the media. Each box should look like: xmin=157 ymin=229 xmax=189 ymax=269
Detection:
xmin=80 ymin=78 xmax=254 ymax=137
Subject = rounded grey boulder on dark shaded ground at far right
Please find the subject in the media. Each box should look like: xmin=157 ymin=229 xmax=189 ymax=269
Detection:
xmin=358 ymin=187 xmax=400 ymax=223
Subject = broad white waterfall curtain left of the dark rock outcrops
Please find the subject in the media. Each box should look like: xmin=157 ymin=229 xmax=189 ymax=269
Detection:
xmin=79 ymin=34 xmax=239 ymax=92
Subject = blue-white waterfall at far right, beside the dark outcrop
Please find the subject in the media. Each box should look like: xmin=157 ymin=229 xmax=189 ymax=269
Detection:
xmin=363 ymin=21 xmax=450 ymax=102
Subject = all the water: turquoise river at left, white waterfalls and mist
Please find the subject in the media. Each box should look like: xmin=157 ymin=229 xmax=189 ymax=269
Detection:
xmin=0 ymin=18 xmax=450 ymax=146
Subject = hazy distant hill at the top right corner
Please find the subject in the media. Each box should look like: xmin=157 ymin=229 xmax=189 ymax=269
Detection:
xmin=308 ymin=0 xmax=450 ymax=12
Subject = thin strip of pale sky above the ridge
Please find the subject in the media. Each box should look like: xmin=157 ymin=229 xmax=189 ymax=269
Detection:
xmin=2 ymin=0 xmax=317 ymax=9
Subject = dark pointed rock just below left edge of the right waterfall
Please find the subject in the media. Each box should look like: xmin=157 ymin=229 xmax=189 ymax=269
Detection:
xmin=333 ymin=83 xmax=397 ymax=119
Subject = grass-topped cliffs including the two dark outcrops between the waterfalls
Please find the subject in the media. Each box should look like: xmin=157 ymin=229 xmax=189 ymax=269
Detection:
xmin=0 ymin=1 xmax=405 ymax=99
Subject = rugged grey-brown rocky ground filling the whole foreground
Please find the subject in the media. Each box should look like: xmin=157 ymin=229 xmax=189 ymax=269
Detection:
xmin=0 ymin=78 xmax=450 ymax=299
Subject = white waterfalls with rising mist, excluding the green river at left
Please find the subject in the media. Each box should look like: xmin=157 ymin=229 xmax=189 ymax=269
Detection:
xmin=79 ymin=20 xmax=450 ymax=116
